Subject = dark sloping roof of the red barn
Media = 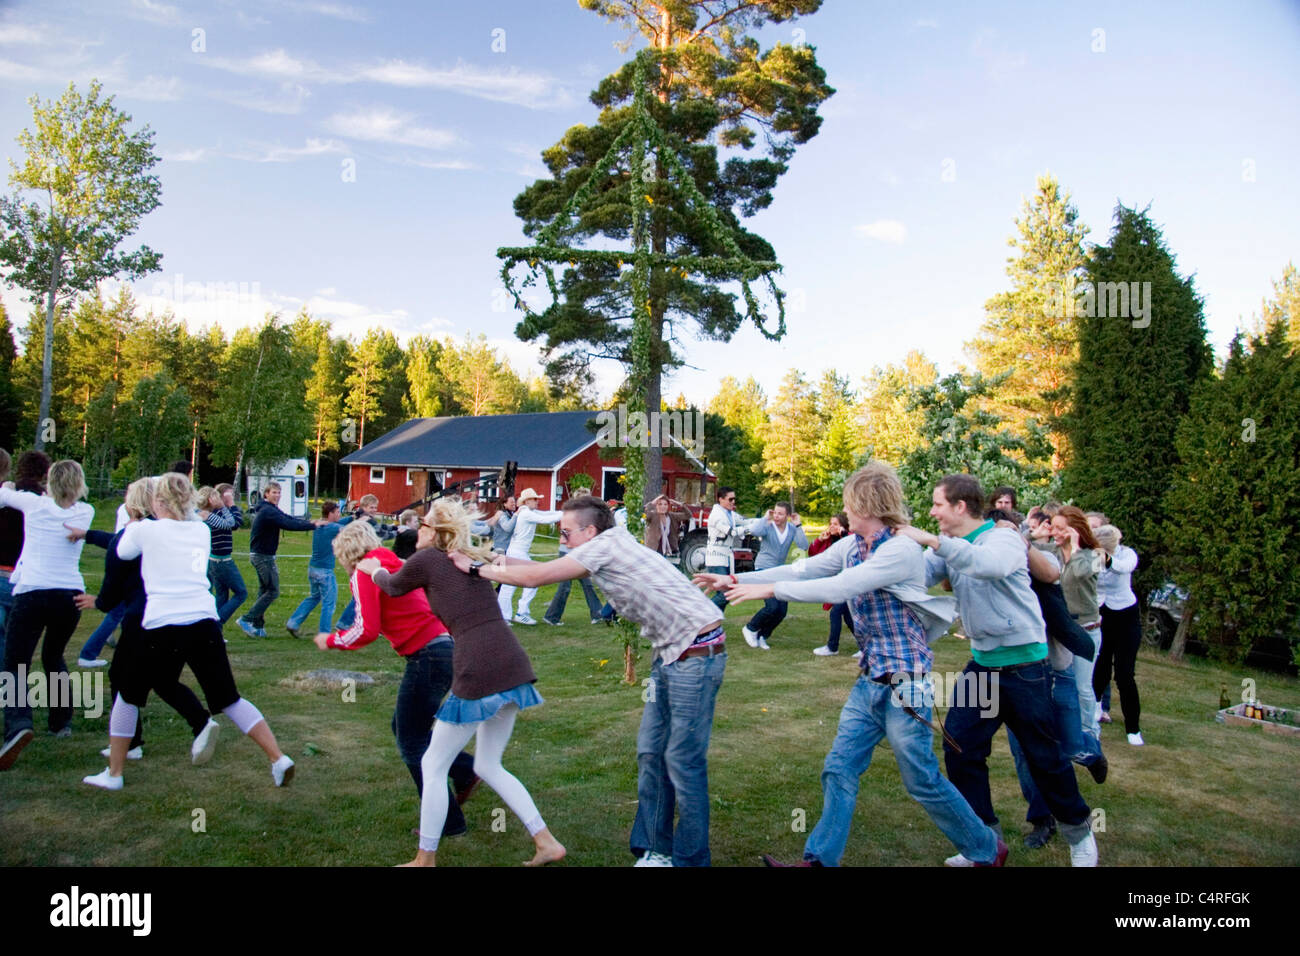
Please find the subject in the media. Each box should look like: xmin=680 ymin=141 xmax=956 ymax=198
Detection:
xmin=342 ymin=411 xmax=598 ymax=471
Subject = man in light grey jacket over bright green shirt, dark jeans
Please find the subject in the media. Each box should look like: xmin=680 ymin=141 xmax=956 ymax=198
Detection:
xmin=898 ymin=475 xmax=1097 ymax=866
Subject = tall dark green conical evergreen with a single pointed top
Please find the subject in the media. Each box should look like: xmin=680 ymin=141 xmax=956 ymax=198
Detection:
xmin=1063 ymin=206 xmax=1212 ymax=591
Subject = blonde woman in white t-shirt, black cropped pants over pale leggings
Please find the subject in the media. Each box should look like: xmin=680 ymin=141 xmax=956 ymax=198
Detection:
xmin=83 ymin=472 xmax=294 ymax=790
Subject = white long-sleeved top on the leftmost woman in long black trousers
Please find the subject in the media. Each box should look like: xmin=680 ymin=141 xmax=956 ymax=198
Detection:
xmin=0 ymin=488 xmax=95 ymax=594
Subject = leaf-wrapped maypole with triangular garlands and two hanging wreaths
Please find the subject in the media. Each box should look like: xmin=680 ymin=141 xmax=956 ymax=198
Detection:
xmin=497 ymin=51 xmax=785 ymax=674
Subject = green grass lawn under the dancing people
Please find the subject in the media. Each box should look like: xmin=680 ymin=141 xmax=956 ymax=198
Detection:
xmin=0 ymin=506 xmax=1300 ymax=866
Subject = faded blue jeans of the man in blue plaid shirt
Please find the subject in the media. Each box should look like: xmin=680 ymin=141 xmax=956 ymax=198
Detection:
xmin=803 ymin=676 xmax=997 ymax=866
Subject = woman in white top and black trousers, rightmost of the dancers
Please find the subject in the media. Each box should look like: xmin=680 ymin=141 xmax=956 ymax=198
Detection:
xmin=1092 ymin=524 xmax=1144 ymax=747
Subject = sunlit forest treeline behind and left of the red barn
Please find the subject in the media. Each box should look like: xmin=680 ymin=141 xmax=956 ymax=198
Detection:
xmin=0 ymin=290 xmax=592 ymax=502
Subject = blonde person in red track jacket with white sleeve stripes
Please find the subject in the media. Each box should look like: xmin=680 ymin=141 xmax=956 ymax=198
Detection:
xmin=316 ymin=520 xmax=478 ymax=836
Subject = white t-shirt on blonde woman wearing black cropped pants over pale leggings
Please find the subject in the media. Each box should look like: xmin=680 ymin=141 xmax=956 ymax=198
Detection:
xmin=117 ymin=518 xmax=217 ymax=628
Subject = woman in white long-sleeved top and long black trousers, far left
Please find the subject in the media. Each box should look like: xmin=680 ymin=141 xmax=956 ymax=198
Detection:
xmin=0 ymin=460 xmax=95 ymax=770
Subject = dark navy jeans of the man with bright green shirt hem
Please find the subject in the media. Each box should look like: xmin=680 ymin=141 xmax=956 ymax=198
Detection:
xmin=944 ymin=659 xmax=1091 ymax=844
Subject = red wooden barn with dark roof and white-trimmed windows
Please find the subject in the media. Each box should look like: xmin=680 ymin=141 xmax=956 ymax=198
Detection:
xmin=342 ymin=411 xmax=716 ymax=514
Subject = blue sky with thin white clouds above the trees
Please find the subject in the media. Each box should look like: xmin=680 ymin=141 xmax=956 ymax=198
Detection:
xmin=0 ymin=0 xmax=1300 ymax=405
